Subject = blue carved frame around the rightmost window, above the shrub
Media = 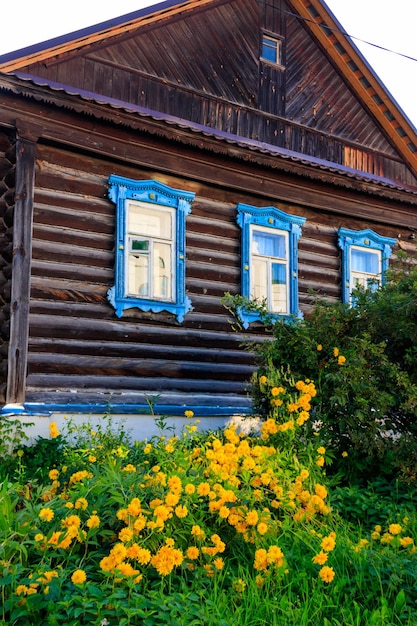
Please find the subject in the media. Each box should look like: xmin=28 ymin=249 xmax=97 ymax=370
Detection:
xmin=338 ymin=228 xmax=397 ymax=303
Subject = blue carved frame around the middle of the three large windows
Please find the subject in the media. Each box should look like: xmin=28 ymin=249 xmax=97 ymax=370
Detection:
xmin=237 ymin=203 xmax=306 ymax=328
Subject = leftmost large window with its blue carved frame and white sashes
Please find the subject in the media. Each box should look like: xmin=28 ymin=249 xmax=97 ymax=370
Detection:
xmin=108 ymin=175 xmax=194 ymax=322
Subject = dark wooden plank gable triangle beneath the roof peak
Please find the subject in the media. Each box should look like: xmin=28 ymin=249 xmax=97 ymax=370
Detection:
xmin=9 ymin=0 xmax=404 ymax=171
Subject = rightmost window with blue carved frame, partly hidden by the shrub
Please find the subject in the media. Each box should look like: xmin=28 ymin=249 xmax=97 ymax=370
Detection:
xmin=339 ymin=228 xmax=396 ymax=302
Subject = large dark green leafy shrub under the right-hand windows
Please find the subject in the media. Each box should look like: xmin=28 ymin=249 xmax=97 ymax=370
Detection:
xmin=224 ymin=250 xmax=417 ymax=480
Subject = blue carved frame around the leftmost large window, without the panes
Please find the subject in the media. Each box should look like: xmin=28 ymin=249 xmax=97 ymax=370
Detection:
xmin=107 ymin=174 xmax=195 ymax=323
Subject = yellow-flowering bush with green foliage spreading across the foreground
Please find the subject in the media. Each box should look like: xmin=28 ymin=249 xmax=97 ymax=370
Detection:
xmin=0 ymin=390 xmax=417 ymax=626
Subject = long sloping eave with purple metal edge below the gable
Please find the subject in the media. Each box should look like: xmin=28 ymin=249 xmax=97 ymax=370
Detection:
xmin=0 ymin=72 xmax=417 ymax=204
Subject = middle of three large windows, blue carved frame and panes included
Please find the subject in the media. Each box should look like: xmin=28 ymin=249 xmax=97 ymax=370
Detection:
xmin=237 ymin=204 xmax=305 ymax=328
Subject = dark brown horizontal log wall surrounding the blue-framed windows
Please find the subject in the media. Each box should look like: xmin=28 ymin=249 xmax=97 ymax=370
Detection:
xmin=20 ymin=142 xmax=412 ymax=406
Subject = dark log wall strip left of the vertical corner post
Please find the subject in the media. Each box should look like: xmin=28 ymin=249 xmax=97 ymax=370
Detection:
xmin=0 ymin=130 xmax=16 ymax=403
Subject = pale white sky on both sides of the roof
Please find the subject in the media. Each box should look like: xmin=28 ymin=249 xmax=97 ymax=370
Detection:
xmin=0 ymin=0 xmax=417 ymax=127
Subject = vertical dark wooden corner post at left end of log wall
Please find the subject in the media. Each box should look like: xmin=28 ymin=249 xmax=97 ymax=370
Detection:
xmin=5 ymin=122 xmax=39 ymax=410
